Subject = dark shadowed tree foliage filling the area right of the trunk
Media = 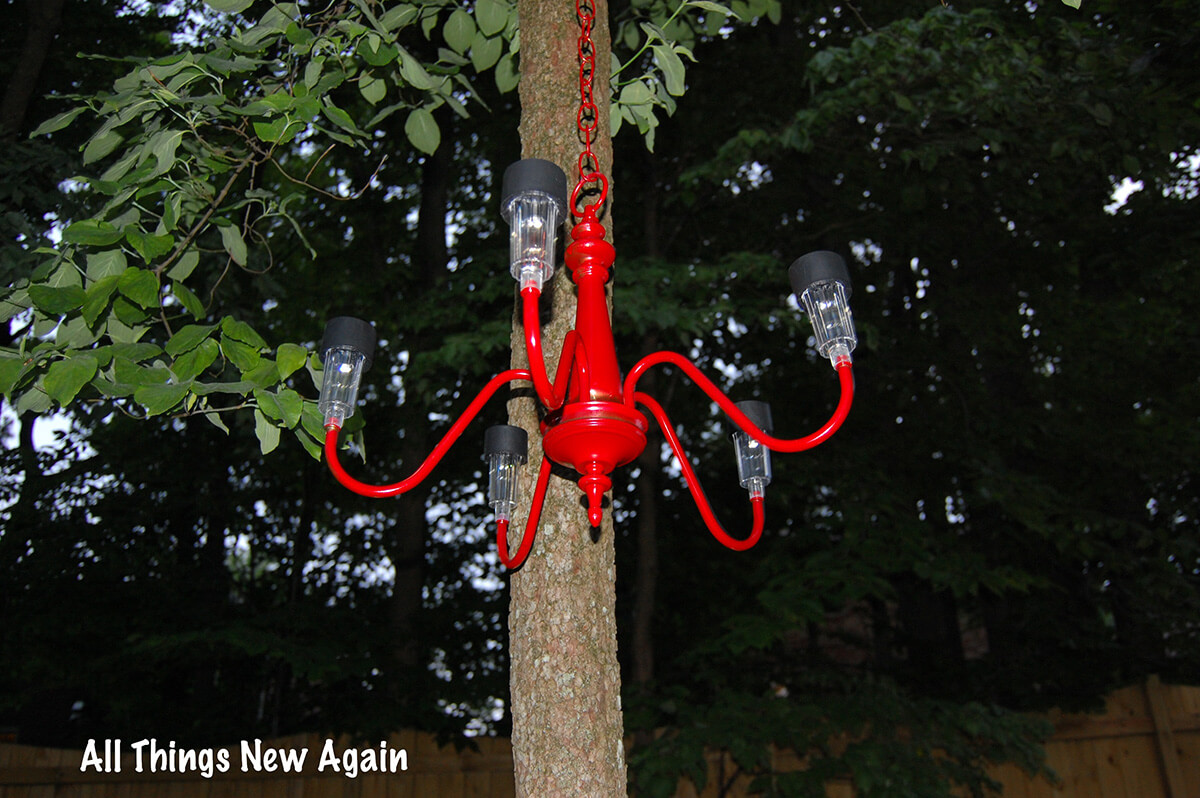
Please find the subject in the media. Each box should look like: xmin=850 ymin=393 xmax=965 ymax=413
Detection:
xmin=614 ymin=2 xmax=1200 ymax=796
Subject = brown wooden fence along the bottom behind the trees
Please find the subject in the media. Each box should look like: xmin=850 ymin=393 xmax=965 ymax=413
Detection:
xmin=0 ymin=678 xmax=1200 ymax=798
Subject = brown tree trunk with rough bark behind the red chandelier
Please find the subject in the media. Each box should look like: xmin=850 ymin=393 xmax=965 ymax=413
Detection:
xmin=509 ymin=0 xmax=626 ymax=798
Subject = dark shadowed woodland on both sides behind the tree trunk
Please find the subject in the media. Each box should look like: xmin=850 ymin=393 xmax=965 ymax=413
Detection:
xmin=0 ymin=0 xmax=1200 ymax=796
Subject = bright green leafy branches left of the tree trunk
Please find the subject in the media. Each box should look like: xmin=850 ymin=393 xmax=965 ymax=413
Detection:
xmin=0 ymin=0 xmax=516 ymax=455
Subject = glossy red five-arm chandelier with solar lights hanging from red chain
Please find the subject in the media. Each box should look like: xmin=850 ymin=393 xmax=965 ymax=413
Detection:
xmin=319 ymin=2 xmax=857 ymax=569
